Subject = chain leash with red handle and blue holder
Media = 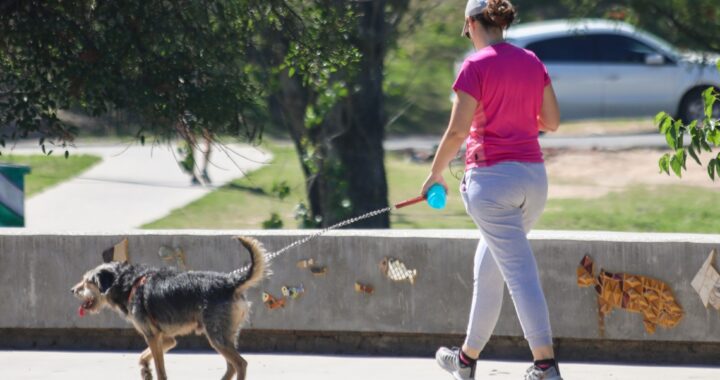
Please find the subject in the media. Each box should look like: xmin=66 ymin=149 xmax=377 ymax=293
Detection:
xmin=235 ymin=183 xmax=446 ymax=272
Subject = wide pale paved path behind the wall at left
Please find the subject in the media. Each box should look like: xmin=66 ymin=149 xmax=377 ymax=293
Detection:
xmin=13 ymin=144 xmax=269 ymax=232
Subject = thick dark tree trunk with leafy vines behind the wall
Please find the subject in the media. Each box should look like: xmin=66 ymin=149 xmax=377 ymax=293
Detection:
xmin=270 ymin=0 xmax=409 ymax=228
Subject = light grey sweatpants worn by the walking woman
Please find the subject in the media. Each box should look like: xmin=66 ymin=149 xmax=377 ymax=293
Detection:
xmin=460 ymin=162 xmax=552 ymax=350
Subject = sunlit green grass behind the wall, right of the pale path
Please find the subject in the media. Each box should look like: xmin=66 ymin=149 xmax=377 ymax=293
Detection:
xmin=144 ymin=147 xmax=720 ymax=233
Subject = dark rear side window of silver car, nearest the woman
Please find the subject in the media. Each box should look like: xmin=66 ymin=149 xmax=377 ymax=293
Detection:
xmin=526 ymin=35 xmax=600 ymax=63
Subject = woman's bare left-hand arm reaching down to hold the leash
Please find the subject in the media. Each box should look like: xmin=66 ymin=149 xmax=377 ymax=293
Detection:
xmin=422 ymin=91 xmax=478 ymax=195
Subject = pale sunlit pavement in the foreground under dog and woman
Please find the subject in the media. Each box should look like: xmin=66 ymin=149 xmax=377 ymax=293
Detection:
xmin=0 ymin=351 xmax=720 ymax=380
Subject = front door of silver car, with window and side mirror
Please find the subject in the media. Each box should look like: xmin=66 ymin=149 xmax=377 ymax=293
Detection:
xmin=595 ymin=34 xmax=682 ymax=117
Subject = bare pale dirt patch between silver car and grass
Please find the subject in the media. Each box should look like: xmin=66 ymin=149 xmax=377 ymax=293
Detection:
xmin=545 ymin=149 xmax=720 ymax=199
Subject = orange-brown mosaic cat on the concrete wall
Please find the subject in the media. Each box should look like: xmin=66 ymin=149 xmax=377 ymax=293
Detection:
xmin=577 ymin=256 xmax=683 ymax=336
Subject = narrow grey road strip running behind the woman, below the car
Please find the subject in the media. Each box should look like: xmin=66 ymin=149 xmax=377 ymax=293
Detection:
xmin=384 ymin=133 xmax=666 ymax=150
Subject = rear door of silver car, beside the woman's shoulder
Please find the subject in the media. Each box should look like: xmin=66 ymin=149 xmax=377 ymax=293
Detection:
xmin=525 ymin=34 xmax=605 ymax=120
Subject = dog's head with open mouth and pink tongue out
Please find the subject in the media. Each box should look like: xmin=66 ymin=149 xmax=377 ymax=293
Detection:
xmin=70 ymin=262 xmax=123 ymax=315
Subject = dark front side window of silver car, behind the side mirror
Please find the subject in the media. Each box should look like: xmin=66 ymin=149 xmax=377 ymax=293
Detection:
xmin=594 ymin=34 xmax=659 ymax=65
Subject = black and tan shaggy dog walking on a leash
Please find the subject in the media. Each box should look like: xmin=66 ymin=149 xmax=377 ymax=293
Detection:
xmin=71 ymin=237 xmax=269 ymax=380
